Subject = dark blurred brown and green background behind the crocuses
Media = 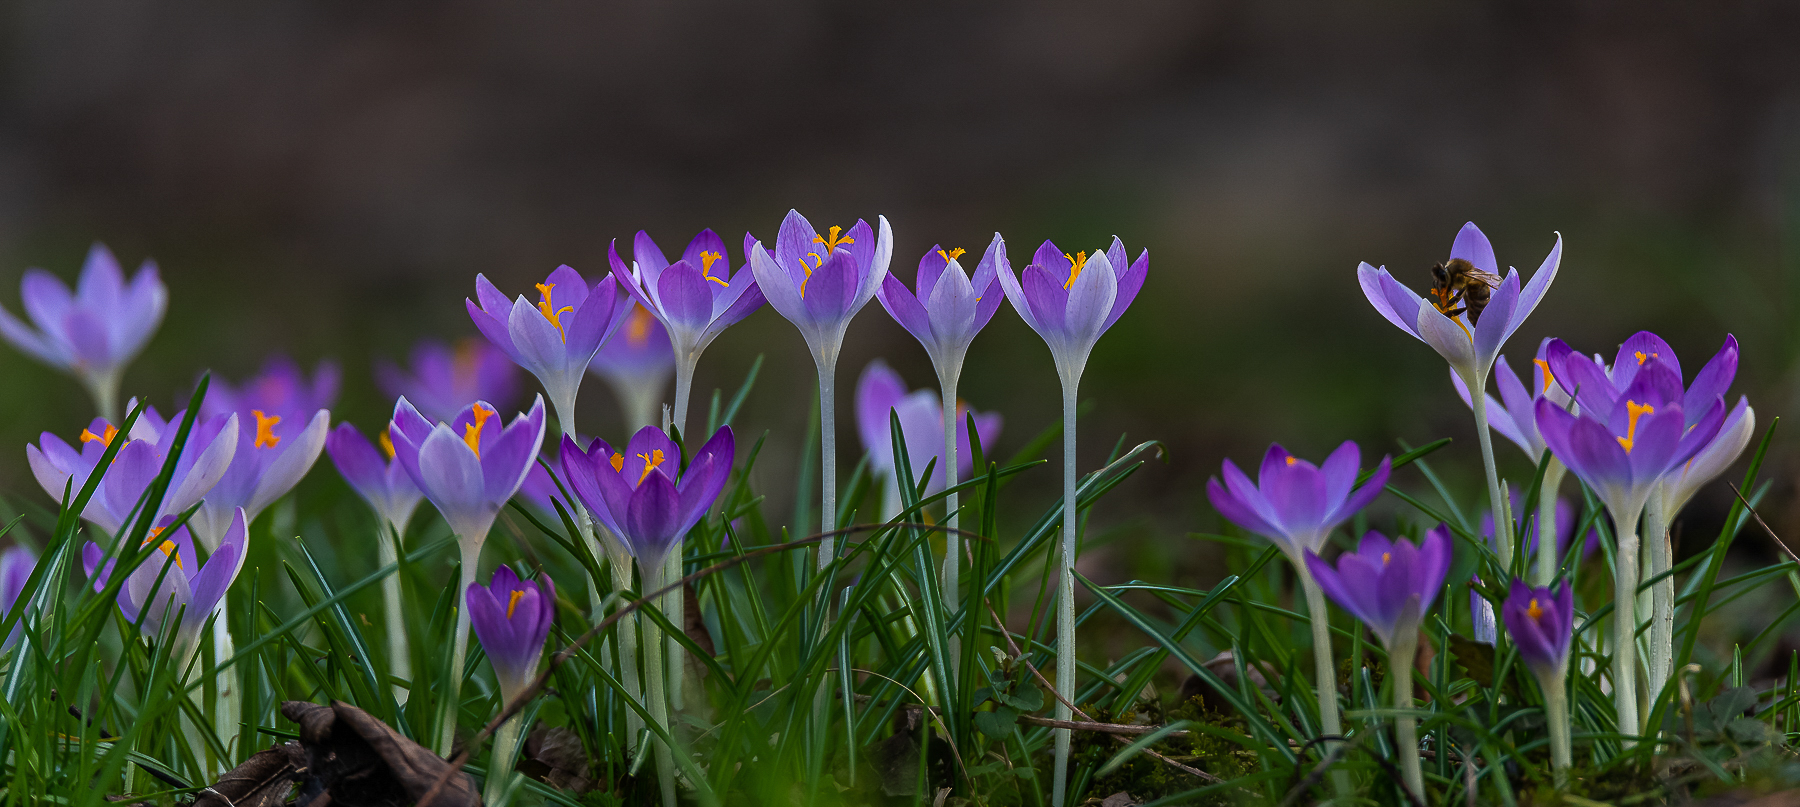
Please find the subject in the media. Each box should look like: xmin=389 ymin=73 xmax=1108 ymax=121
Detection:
xmin=0 ymin=0 xmax=1800 ymax=601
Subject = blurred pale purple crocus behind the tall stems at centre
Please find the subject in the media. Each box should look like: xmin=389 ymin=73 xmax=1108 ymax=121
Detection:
xmin=857 ymin=358 xmax=1001 ymax=494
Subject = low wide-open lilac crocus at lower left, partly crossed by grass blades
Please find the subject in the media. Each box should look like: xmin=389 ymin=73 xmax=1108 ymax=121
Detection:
xmin=81 ymin=510 xmax=250 ymax=659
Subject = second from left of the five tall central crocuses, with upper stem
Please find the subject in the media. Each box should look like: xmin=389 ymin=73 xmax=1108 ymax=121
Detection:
xmin=607 ymin=229 xmax=766 ymax=434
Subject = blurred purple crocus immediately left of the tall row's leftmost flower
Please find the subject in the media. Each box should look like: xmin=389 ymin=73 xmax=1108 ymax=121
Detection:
xmin=374 ymin=337 xmax=518 ymax=420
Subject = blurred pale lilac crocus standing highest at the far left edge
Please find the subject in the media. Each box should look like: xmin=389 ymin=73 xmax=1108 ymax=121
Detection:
xmin=0 ymin=243 xmax=169 ymax=422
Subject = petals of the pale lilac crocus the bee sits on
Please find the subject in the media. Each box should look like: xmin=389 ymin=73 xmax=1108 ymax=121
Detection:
xmin=1355 ymin=222 xmax=1562 ymax=389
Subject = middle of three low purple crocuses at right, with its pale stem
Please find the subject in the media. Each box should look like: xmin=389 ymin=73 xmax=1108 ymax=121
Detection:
xmin=1307 ymin=524 xmax=1451 ymax=794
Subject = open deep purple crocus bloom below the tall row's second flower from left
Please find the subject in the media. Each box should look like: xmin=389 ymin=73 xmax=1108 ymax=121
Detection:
xmin=562 ymin=427 xmax=736 ymax=575
